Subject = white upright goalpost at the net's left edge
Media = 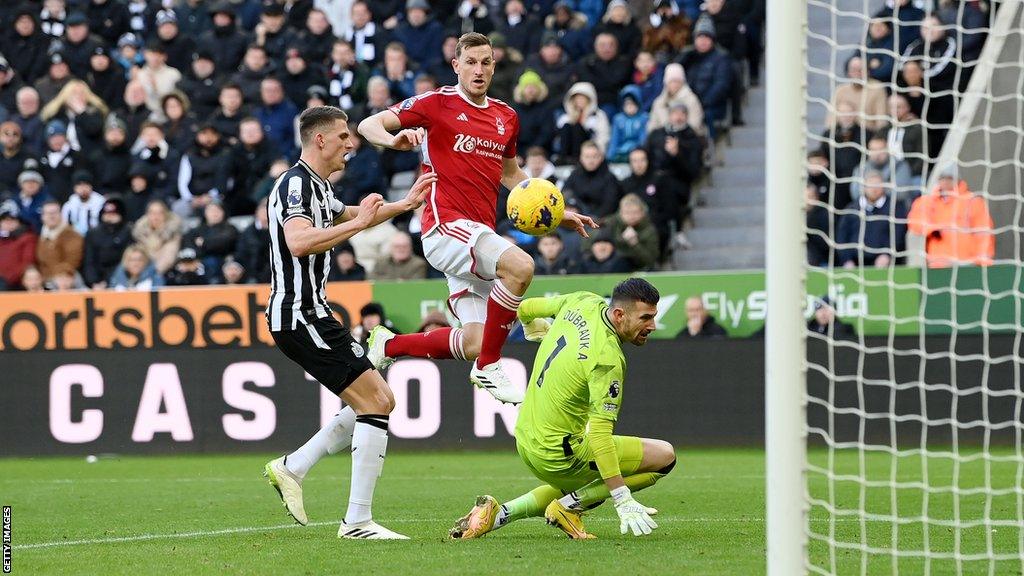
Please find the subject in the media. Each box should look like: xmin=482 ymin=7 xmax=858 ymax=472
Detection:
xmin=765 ymin=0 xmax=807 ymax=576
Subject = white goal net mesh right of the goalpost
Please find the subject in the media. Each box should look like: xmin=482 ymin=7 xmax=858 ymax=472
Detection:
xmin=802 ymin=0 xmax=1024 ymax=575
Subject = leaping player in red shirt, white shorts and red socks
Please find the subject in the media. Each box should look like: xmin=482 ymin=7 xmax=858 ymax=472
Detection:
xmin=359 ymin=33 xmax=596 ymax=404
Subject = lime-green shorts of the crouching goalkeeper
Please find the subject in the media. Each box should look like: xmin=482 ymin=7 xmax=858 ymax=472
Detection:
xmin=516 ymin=436 xmax=643 ymax=493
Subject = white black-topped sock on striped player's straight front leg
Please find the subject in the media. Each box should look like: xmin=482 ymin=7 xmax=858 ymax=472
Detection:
xmin=345 ymin=414 xmax=388 ymax=525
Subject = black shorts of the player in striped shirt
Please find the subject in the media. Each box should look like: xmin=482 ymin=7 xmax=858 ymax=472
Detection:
xmin=270 ymin=316 xmax=374 ymax=395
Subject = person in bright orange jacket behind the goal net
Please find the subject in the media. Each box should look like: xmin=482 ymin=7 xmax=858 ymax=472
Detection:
xmin=907 ymin=167 xmax=995 ymax=268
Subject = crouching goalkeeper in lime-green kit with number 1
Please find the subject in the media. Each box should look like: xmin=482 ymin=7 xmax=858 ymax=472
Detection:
xmin=450 ymin=278 xmax=676 ymax=539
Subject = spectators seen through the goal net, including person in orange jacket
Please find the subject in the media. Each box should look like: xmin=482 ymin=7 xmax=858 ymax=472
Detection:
xmin=805 ymin=0 xmax=994 ymax=268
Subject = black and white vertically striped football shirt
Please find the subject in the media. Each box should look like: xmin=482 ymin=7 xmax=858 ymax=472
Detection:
xmin=266 ymin=160 xmax=345 ymax=332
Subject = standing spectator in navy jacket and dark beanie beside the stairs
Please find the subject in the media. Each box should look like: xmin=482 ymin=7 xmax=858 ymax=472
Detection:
xmin=679 ymin=18 xmax=733 ymax=138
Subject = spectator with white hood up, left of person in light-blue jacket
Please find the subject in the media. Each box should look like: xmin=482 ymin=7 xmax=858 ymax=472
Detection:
xmin=555 ymin=82 xmax=611 ymax=164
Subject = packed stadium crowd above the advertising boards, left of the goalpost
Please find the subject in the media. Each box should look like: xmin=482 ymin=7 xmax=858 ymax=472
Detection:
xmin=0 ymin=0 xmax=764 ymax=290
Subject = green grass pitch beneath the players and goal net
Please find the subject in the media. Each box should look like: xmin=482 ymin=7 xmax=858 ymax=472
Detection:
xmin=0 ymin=450 xmax=1021 ymax=576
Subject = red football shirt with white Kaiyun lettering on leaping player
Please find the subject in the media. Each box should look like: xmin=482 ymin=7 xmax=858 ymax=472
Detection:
xmin=390 ymin=86 xmax=519 ymax=235
